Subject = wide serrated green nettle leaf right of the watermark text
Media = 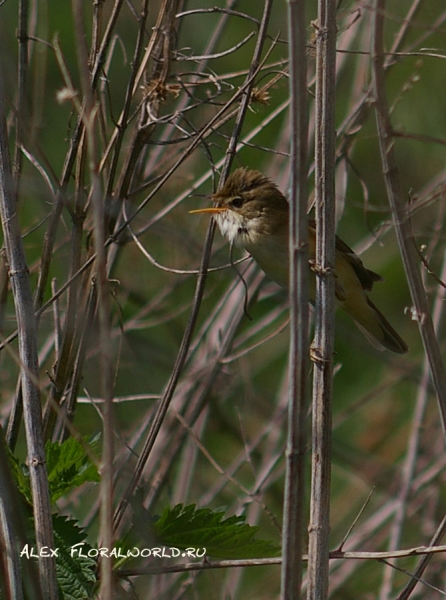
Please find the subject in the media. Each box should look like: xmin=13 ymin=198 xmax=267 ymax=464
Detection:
xmin=154 ymin=504 xmax=281 ymax=559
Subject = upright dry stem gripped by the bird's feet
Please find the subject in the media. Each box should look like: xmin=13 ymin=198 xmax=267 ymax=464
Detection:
xmin=307 ymin=0 xmax=336 ymax=599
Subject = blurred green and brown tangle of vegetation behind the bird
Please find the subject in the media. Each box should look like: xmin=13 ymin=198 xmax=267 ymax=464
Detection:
xmin=0 ymin=0 xmax=446 ymax=600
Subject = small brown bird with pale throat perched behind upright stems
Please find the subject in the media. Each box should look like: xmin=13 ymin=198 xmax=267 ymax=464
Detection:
xmin=190 ymin=167 xmax=408 ymax=354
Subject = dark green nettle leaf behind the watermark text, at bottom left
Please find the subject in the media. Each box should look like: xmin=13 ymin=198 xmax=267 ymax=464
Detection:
xmin=53 ymin=515 xmax=97 ymax=600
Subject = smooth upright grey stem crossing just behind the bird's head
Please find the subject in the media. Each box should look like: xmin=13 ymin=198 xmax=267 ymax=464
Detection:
xmin=281 ymin=0 xmax=309 ymax=600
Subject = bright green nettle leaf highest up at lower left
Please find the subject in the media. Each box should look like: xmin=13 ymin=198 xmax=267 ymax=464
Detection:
xmin=45 ymin=438 xmax=100 ymax=502
